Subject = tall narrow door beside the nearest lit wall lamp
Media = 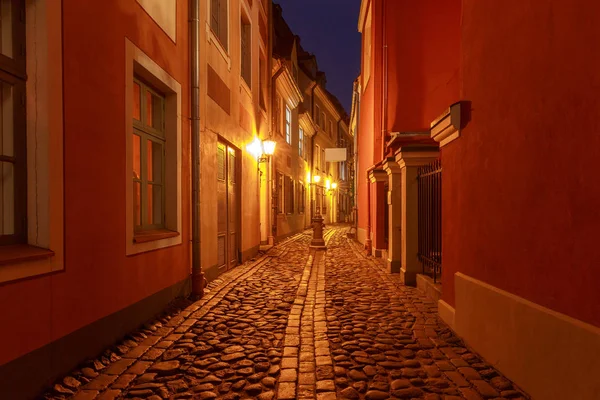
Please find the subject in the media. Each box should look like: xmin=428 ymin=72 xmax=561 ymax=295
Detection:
xmin=217 ymin=142 xmax=239 ymax=270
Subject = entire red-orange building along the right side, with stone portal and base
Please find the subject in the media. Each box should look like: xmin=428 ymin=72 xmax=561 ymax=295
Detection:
xmin=353 ymin=0 xmax=600 ymax=399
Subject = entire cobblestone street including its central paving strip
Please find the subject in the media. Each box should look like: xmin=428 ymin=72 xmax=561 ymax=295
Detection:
xmin=44 ymin=227 xmax=525 ymax=400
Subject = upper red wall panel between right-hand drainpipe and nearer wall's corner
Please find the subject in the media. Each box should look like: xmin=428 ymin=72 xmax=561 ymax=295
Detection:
xmin=385 ymin=0 xmax=461 ymax=132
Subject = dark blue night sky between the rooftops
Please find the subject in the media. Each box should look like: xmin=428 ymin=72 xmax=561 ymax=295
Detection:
xmin=275 ymin=0 xmax=360 ymax=114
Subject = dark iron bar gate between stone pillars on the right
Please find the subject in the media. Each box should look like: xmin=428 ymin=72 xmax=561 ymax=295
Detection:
xmin=418 ymin=159 xmax=442 ymax=282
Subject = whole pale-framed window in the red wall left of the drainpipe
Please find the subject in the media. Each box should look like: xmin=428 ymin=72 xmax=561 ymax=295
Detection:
xmin=124 ymin=40 xmax=183 ymax=255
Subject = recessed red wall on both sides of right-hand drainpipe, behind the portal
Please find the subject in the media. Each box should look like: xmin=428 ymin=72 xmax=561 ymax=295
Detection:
xmin=358 ymin=0 xmax=460 ymax=240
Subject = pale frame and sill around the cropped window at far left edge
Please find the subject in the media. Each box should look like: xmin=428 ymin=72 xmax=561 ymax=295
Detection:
xmin=0 ymin=0 xmax=65 ymax=283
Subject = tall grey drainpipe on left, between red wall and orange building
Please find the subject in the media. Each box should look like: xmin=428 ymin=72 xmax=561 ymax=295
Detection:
xmin=190 ymin=0 xmax=205 ymax=299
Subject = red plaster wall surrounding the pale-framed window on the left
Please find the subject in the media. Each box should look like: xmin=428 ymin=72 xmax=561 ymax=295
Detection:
xmin=0 ymin=0 xmax=190 ymax=364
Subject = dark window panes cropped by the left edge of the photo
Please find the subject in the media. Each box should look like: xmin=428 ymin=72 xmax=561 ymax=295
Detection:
xmin=0 ymin=0 xmax=27 ymax=245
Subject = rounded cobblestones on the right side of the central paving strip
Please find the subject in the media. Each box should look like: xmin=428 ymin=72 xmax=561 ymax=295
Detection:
xmin=326 ymin=231 xmax=527 ymax=400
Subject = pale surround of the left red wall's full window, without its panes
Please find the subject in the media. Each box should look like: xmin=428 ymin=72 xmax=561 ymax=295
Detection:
xmin=125 ymin=38 xmax=182 ymax=255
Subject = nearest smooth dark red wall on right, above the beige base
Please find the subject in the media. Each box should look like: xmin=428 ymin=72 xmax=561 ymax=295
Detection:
xmin=443 ymin=0 xmax=600 ymax=326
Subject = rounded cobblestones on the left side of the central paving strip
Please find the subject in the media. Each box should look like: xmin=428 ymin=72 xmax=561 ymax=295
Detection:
xmin=43 ymin=234 xmax=310 ymax=400
